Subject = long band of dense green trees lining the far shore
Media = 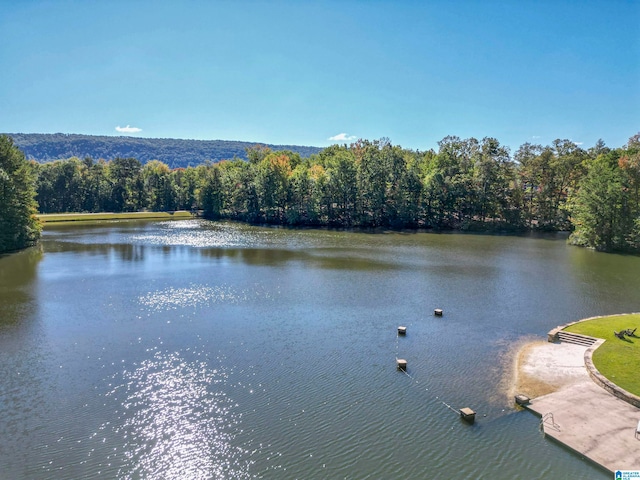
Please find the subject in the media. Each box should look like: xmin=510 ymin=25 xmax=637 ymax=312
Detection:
xmin=26 ymin=134 xmax=640 ymax=252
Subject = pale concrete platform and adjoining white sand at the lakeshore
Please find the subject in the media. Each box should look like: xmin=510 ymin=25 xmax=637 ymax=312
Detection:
xmin=526 ymin=341 xmax=640 ymax=473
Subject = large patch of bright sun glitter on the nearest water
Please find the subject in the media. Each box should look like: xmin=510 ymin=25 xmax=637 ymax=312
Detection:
xmin=101 ymin=352 xmax=252 ymax=479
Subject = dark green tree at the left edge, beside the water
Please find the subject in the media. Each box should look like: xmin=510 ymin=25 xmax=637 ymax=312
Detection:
xmin=0 ymin=135 xmax=40 ymax=252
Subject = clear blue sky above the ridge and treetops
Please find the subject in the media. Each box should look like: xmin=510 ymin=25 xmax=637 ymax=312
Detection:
xmin=0 ymin=0 xmax=640 ymax=152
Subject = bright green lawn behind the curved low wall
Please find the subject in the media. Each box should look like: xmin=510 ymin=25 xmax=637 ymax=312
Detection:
xmin=564 ymin=314 xmax=640 ymax=396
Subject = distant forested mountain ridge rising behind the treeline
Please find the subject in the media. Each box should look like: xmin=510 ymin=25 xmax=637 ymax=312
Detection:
xmin=6 ymin=133 xmax=322 ymax=168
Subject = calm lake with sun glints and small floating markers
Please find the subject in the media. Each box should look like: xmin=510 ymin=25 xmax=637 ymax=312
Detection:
xmin=0 ymin=220 xmax=640 ymax=480
